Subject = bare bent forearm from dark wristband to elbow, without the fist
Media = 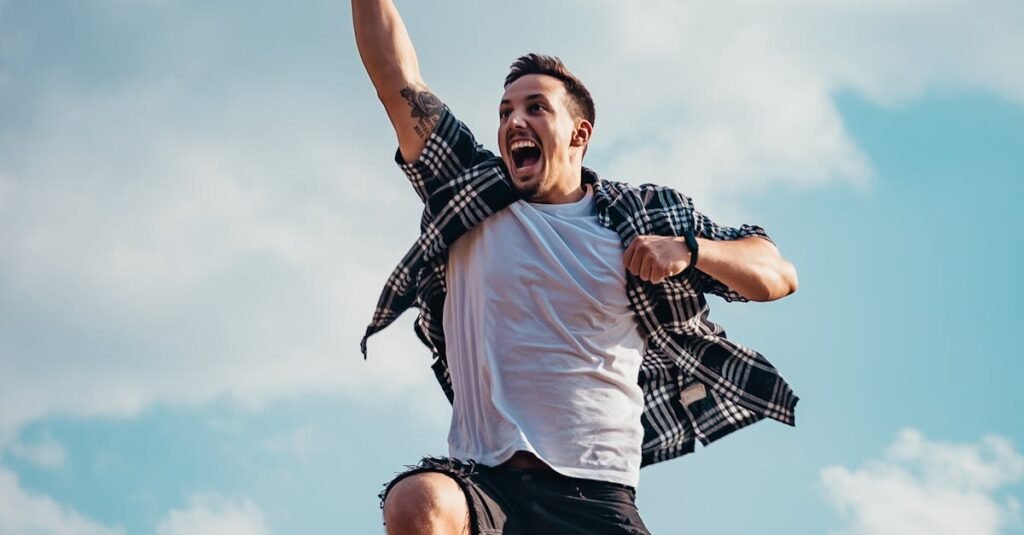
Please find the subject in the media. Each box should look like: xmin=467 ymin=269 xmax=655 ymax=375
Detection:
xmin=696 ymin=237 xmax=798 ymax=301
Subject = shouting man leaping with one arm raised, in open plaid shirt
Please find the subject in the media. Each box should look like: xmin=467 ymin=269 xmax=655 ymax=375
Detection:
xmin=352 ymin=0 xmax=797 ymax=534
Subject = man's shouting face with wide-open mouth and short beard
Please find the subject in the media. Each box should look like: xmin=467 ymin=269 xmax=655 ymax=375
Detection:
xmin=498 ymin=75 xmax=582 ymax=202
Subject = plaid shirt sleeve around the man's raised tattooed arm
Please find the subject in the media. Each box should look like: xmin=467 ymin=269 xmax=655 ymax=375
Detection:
xmin=394 ymin=106 xmax=494 ymax=202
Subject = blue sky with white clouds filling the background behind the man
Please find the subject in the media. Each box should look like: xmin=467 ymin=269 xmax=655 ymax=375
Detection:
xmin=0 ymin=0 xmax=1024 ymax=535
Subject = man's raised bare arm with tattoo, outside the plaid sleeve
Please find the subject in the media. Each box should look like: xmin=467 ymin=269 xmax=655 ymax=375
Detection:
xmin=352 ymin=0 xmax=443 ymax=162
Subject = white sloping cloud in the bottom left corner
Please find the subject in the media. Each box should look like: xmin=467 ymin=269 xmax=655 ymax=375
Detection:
xmin=0 ymin=466 xmax=124 ymax=535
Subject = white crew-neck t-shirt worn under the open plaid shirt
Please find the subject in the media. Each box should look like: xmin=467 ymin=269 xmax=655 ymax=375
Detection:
xmin=443 ymin=184 xmax=644 ymax=487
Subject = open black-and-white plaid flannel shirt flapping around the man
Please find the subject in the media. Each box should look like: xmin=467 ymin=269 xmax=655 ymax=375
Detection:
xmin=360 ymin=108 xmax=798 ymax=465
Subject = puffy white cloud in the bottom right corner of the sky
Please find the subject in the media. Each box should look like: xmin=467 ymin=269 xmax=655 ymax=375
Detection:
xmin=821 ymin=429 xmax=1024 ymax=535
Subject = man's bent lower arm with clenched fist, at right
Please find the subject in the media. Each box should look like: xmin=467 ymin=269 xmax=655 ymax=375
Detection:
xmin=625 ymin=236 xmax=798 ymax=301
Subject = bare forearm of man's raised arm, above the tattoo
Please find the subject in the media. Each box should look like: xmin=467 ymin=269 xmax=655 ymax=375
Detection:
xmin=352 ymin=0 xmax=421 ymax=93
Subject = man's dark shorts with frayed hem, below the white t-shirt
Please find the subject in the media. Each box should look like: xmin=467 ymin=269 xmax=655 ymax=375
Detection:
xmin=380 ymin=457 xmax=650 ymax=535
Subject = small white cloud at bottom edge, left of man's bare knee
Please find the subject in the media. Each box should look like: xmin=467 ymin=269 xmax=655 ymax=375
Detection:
xmin=157 ymin=495 xmax=269 ymax=535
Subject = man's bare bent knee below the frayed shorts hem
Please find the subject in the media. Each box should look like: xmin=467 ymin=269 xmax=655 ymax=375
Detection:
xmin=384 ymin=471 xmax=469 ymax=533
